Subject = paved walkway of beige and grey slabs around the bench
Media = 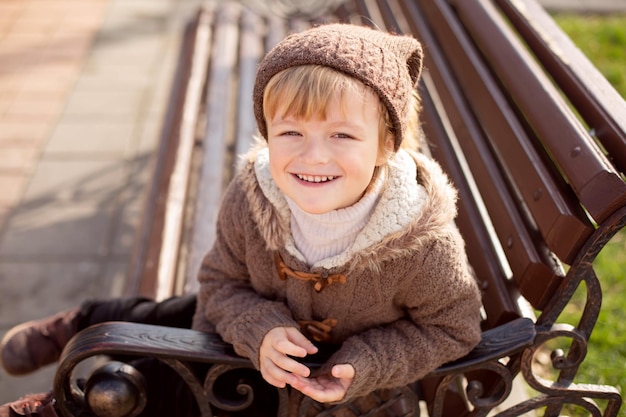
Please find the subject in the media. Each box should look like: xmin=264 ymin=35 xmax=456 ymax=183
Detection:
xmin=0 ymin=0 xmax=626 ymax=403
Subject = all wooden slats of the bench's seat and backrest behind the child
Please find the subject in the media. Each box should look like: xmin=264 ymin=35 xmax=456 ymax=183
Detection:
xmin=129 ymin=0 xmax=626 ymax=334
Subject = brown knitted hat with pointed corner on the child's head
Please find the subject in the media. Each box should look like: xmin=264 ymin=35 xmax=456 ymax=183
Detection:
xmin=253 ymin=23 xmax=423 ymax=150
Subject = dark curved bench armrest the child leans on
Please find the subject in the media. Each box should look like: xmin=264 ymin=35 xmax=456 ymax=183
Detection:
xmin=54 ymin=319 xmax=535 ymax=416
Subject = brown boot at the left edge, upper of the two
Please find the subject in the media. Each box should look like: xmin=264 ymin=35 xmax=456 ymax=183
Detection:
xmin=0 ymin=308 xmax=79 ymax=375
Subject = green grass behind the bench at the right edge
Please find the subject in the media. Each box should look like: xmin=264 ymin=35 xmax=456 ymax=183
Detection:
xmin=554 ymin=14 xmax=626 ymax=417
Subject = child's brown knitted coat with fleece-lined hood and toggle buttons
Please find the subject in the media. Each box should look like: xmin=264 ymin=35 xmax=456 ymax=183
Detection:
xmin=194 ymin=145 xmax=480 ymax=401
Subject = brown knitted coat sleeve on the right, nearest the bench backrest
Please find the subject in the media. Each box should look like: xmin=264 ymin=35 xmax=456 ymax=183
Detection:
xmin=322 ymin=231 xmax=481 ymax=402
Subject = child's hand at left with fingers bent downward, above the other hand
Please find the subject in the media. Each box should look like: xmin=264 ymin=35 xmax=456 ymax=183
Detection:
xmin=259 ymin=327 xmax=317 ymax=388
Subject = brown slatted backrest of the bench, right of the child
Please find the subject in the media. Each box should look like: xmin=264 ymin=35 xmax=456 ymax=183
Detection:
xmin=402 ymin=0 xmax=626 ymax=325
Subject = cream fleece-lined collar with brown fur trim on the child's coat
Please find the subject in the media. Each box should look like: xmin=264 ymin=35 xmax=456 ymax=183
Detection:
xmin=236 ymin=145 xmax=456 ymax=269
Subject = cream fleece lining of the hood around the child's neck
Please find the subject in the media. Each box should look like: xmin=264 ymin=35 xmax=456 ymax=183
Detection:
xmin=254 ymin=148 xmax=427 ymax=268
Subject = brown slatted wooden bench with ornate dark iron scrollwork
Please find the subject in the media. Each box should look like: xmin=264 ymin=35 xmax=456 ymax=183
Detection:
xmin=54 ymin=0 xmax=626 ymax=417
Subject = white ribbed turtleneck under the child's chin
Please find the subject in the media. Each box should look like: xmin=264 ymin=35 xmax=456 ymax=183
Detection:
xmin=287 ymin=170 xmax=385 ymax=265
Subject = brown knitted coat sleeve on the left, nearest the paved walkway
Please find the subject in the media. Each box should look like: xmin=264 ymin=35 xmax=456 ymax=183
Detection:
xmin=193 ymin=180 xmax=298 ymax=369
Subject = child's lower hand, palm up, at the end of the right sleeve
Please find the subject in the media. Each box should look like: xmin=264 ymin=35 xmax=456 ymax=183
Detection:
xmin=290 ymin=364 xmax=355 ymax=403
